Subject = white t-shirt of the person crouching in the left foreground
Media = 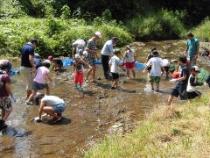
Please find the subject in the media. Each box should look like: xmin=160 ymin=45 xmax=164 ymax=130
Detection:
xmin=41 ymin=95 xmax=65 ymax=107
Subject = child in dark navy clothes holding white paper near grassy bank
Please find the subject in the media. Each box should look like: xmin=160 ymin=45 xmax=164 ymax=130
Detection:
xmin=168 ymin=56 xmax=189 ymax=105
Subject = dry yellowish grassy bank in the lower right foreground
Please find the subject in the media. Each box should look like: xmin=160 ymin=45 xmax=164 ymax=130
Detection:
xmin=85 ymin=94 xmax=210 ymax=158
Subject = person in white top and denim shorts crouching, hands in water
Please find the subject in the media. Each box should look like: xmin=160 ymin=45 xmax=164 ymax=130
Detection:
xmin=35 ymin=94 xmax=65 ymax=122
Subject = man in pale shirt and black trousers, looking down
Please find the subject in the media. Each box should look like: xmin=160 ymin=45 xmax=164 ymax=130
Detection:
xmin=101 ymin=37 xmax=118 ymax=79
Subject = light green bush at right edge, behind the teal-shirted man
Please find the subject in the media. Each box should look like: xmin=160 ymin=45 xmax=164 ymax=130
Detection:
xmin=193 ymin=18 xmax=210 ymax=42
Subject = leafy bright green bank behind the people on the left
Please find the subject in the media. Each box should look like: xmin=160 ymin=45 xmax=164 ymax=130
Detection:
xmin=0 ymin=17 xmax=132 ymax=55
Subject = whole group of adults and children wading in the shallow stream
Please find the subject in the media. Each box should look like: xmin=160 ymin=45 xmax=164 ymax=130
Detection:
xmin=0 ymin=32 xmax=209 ymax=130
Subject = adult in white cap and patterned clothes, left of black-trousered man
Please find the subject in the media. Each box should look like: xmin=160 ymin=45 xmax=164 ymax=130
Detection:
xmin=85 ymin=32 xmax=101 ymax=82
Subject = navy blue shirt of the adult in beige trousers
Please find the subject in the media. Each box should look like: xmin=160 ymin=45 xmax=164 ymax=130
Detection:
xmin=21 ymin=43 xmax=34 ymax=68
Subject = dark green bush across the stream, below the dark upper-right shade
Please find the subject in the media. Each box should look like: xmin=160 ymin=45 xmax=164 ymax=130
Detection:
xmin=127 ymin=10 xmax=185 ymax=40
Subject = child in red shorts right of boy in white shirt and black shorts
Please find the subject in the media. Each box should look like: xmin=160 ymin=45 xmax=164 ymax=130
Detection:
xmin=123 ymin=46 xmax=136 ymax=79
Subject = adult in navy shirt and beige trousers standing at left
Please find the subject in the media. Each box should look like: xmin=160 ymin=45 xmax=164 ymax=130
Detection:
xmin=21 ymin=39 xmax=38 ymax=99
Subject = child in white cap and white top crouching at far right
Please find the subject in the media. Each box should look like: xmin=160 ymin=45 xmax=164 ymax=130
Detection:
xmin=187 ymin=66 xmax=203 ymax=99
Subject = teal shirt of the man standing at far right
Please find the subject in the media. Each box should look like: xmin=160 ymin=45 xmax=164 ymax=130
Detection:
xmin=187 ymin=38 xmax=199 ymax=58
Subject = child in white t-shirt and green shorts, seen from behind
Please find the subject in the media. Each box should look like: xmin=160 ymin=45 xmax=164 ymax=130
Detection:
xmin=146 ymin=51 xmax=162 ymax=92
